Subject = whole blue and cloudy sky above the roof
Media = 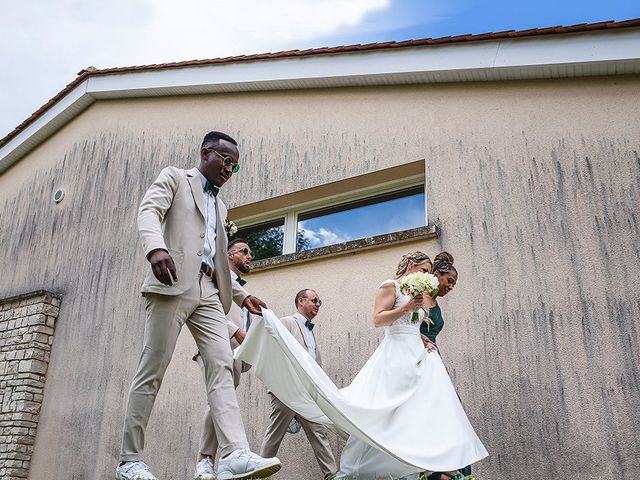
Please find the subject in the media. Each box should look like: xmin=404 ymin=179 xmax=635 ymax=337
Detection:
xmin=0 ymin=0 xmax=640 ymax=138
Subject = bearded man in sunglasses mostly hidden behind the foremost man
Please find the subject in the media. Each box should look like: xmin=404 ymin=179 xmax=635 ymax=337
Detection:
xmin=193 ymin=238 xmax=252 ymax=480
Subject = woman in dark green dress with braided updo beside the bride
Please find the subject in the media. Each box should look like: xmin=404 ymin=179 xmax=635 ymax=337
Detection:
xmin=420 ymin=252 xmax=471 ymax=480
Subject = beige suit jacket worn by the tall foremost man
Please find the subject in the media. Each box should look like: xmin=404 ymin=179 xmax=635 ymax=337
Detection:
xmin=138 ymin=167 xmax=249 ymax=314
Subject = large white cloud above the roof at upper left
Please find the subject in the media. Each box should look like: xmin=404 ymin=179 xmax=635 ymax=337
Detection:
xmin=0 ymin=0 xmax=389 ymax=137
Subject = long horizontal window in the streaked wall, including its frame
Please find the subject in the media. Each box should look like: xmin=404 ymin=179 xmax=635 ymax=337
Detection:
xmin=229 ymin=160 xmax=428 ymax=260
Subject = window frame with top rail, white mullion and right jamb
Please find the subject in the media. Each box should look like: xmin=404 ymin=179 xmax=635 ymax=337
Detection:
xmin=234 ymin=174 xmax=429 ymax=255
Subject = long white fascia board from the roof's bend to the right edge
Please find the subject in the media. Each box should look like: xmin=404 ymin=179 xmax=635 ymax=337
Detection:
xmin=87 ymin=29 xmax=640 ymax=98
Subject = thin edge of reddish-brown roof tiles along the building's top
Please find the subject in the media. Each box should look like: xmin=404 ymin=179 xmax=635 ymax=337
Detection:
xmin=0 ymin=18 xmax=640 ymax=147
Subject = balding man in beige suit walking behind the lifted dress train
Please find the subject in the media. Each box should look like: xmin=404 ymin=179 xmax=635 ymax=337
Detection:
xmin=260 ymin=289 xmax=338 ymax=479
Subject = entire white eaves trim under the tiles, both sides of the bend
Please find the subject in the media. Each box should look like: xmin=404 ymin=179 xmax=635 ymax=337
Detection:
xmin=0 ymin=28 xmax=640 ymax=173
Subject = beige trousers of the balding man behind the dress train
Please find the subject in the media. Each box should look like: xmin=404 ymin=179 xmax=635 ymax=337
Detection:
xmin=260 ymin=392 xmax=338 ymax=476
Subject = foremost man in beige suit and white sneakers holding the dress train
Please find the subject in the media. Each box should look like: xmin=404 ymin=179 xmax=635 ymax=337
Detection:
xmin=116 ymin=132 xmax=281 ymax=480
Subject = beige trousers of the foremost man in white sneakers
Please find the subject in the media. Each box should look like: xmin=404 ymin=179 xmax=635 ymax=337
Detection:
xmin=120 ymin=274 xmax=249 ymax=462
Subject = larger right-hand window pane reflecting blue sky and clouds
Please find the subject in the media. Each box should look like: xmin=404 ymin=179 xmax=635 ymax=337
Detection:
xmin=296 ymin=186 xmax=426 ymax=252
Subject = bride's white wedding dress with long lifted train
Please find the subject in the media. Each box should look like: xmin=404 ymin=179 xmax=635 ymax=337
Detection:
xmin=235 ymin=280 xmax=488 ymax=480
